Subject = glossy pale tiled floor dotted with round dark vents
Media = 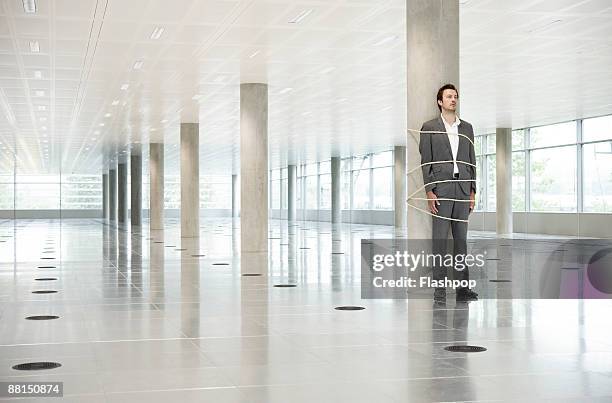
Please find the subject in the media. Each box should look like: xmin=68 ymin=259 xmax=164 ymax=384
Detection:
xmin=0 ymin=219 xmax=612 ymax=403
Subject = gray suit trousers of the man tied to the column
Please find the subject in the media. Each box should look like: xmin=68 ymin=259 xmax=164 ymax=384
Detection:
xmin=432 ymin=182 xmax=470 ymax=280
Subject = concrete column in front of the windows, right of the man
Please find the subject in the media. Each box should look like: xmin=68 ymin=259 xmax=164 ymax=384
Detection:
xmin=498 ymin=128 xmax=512 ymax=235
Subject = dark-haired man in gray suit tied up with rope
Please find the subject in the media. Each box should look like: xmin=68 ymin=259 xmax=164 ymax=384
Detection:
xmin=419 ymin=84 xmax=478 ymax=302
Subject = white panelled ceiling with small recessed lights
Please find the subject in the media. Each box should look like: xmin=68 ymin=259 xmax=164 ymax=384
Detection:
xmin=0 ymin=0 xmax=612 ymax=173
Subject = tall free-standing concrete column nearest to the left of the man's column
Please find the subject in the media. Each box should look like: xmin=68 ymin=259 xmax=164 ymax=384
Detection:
xmin=240 ymin=84 xmax=268 ymax=254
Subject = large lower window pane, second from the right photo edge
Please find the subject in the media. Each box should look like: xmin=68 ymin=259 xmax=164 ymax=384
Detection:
xmin=529 ymin=146 xmax=576 ymax=212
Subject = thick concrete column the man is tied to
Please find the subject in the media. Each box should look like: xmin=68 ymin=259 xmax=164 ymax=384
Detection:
xmin=406 ymin=0 xmax=460 ymax=239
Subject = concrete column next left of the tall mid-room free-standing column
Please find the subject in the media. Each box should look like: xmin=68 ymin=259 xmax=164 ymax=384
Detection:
xmin=181 ymin=123 xmax=200 ymax=238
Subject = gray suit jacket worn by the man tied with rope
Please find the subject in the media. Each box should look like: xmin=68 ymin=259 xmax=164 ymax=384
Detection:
xmin=419 ymin=116 xmax=476 ymax=198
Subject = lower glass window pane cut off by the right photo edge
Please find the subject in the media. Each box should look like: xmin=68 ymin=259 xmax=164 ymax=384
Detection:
xmin=583 ymin=141 xmax=612 ymax=213
